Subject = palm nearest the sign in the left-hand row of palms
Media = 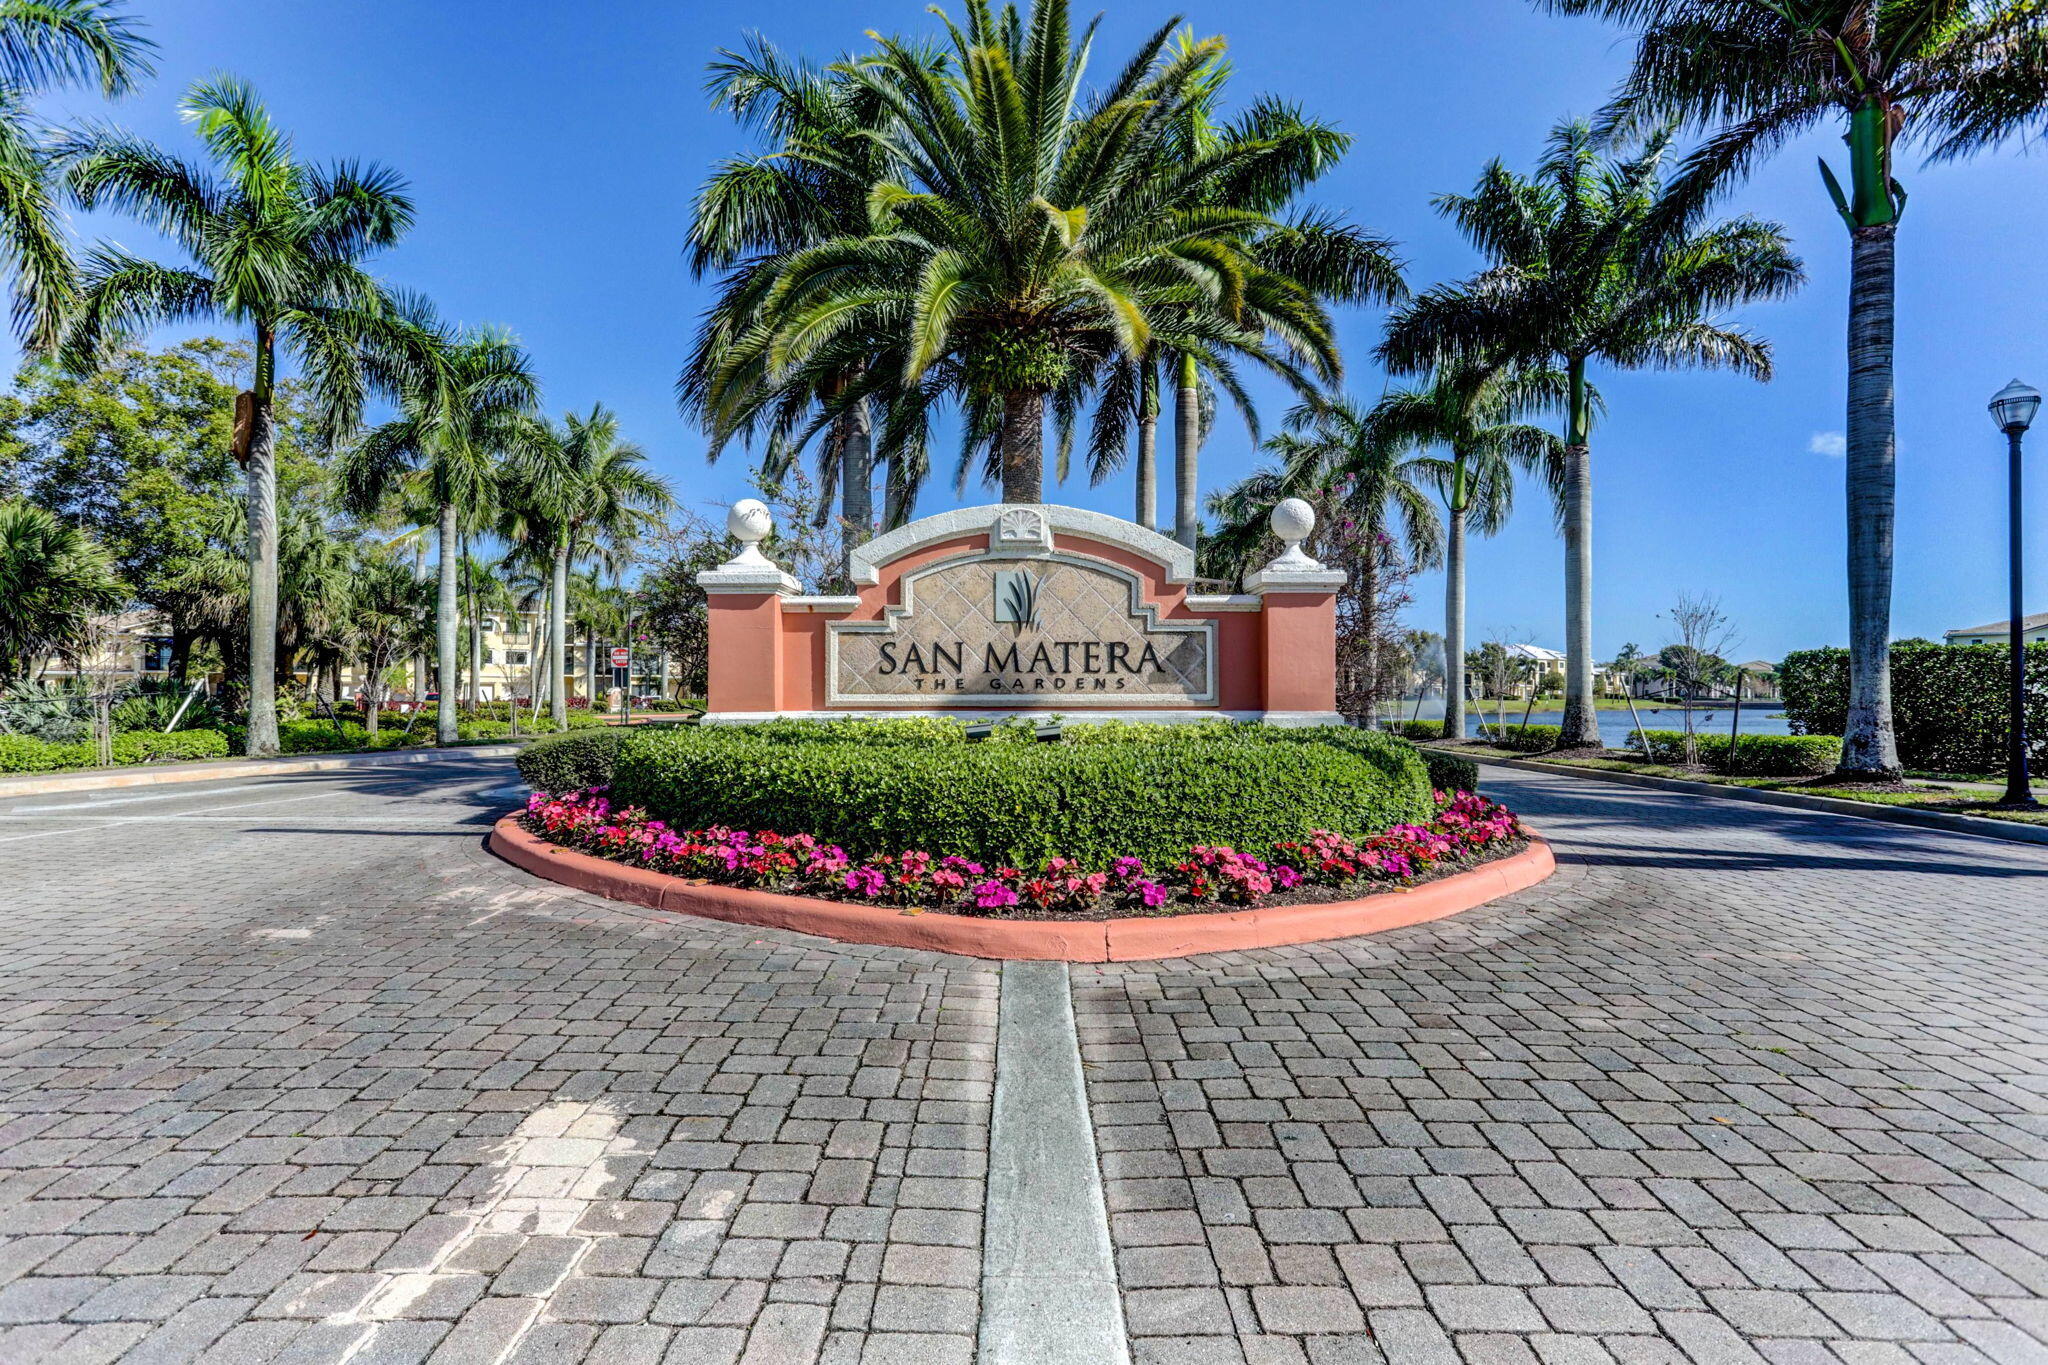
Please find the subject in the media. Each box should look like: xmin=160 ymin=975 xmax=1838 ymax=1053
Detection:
xmin=504 ymin=403 xmax=674 ymax=729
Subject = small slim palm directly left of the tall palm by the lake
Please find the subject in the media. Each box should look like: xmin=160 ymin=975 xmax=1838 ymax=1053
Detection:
xmin=1366 ymin=364 xmax=1565 ymax=739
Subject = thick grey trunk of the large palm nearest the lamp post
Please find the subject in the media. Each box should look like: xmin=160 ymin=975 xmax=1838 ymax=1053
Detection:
xmin=1839 ymin=223 xmax=1901 ymax=782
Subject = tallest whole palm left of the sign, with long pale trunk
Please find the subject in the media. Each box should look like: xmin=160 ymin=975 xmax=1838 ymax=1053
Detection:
xmin=57 ymin=78 xmax=412 ymax=755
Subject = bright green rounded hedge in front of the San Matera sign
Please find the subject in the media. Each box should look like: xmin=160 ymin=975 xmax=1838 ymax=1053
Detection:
xmin=606 ymin=720 xmax=1432 ymax=866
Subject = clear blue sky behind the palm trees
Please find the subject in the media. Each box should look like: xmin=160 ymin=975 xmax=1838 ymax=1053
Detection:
xmin=19 ymin=0 xmax=2048 ymax=659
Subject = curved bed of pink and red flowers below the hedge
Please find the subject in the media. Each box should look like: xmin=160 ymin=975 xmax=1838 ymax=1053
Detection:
xmin=518 ymin=788 xmax=1528 ymax=919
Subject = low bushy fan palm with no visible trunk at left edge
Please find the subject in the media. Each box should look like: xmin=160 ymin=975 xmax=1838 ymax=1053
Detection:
xmin=0 ymin=497 xmax=127 ymax=688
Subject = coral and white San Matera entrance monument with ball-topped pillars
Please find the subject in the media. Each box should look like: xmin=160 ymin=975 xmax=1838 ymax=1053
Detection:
xmin=696 ymin=499 xmax=1343 ymax=724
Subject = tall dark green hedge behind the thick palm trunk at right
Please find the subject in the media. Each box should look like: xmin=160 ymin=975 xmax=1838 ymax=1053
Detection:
xmin=1778 ymin=643 xmax=2048 ymax=774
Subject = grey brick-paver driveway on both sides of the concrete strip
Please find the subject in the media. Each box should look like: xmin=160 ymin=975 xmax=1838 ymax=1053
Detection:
xmin=0 ymin=761 xmax=2048 ymax=1365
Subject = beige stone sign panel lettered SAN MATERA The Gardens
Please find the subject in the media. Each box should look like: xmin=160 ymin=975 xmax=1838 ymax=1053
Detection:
xmin=825 ymin=552 xmax=1217 ymax=708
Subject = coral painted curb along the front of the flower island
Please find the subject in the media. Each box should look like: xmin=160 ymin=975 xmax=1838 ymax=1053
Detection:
xmin=489 ymin=814 xmax=1556 ymax=962
